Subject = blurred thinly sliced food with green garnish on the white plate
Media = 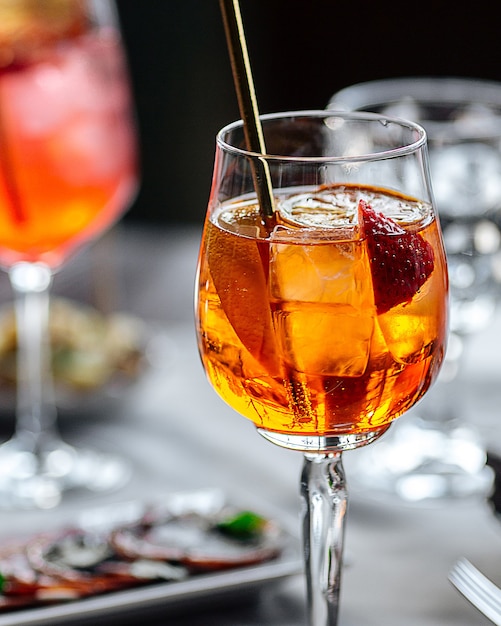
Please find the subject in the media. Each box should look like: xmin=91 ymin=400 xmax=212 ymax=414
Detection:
xmin=0 ymin=507 xmax=283 ymax=610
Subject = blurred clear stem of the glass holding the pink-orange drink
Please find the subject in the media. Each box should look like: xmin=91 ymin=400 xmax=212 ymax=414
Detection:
xmin=9 ymin=263 xmax=56 ymax=454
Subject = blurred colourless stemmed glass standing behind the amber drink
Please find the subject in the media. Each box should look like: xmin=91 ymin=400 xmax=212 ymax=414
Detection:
xmin=328 ymin=77 xmax=501 ymax=502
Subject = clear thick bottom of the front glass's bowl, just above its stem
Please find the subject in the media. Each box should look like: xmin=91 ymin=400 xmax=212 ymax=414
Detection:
xmin=257 ymin=424 xmax=390 ymax=454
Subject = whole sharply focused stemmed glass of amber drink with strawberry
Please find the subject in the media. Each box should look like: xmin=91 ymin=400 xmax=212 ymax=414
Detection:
xmin=196 ymin=111 xmax=447 ymax=626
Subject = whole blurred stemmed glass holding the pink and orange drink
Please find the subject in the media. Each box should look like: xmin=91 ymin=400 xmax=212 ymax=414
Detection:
xmin=0 ymin=0 xmax=137 ymax=508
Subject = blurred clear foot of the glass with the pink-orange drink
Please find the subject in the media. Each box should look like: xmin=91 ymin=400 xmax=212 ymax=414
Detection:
xmin=0 ymin=438 xmax=131 ymax=510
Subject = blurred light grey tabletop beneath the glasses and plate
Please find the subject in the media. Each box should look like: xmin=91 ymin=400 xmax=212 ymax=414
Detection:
xmin=0 ymin=225 xmax=501 ymax=626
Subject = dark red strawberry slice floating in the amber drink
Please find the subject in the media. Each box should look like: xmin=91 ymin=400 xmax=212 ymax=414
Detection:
xmin=359 ymin=200 xmax=434 ymax=314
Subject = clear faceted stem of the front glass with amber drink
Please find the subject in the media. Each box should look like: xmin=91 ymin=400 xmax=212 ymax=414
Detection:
xmin=301 ymin=452 xmax=348 ymax=626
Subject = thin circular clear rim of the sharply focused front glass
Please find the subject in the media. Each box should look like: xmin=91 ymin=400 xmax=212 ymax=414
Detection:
xmin=216 ymin=109 xmax=427 ymax=163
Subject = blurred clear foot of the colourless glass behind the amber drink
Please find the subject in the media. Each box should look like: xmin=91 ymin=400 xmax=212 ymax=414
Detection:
xmin=349 ymin=416 xmax=494 ymax=503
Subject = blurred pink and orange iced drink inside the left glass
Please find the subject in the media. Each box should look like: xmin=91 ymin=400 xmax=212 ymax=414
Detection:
xmin=0 ymin=0 xmax=136 ymax=267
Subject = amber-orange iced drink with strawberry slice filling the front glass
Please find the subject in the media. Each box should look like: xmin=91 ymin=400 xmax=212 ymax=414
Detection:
xmin=198 ymin=185 xmax=447 ymax=436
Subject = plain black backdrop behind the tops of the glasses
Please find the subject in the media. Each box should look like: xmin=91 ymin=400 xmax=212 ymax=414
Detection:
xmin=117 ymin=0 xmax=501 ymax=224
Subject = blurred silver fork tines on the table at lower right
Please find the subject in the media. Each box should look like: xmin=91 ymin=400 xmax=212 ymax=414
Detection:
xmin=449 ymin=558 xmax=501 ymax=626
